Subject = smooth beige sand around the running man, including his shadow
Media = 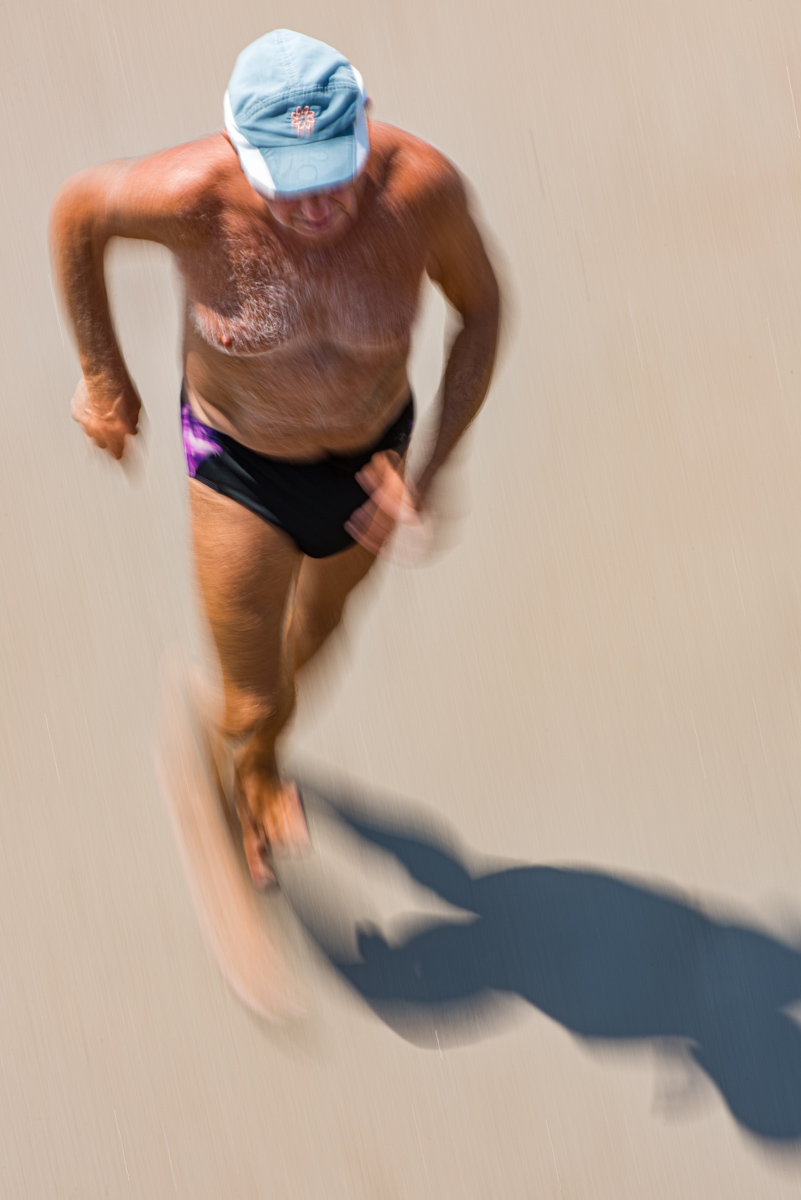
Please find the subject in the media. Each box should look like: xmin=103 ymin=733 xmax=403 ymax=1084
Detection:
xmin=0 ymin=0 xmax=801 ymax=1200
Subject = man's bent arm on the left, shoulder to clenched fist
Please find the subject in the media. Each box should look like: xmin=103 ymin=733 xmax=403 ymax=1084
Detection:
xmin=50 ymin=148 xmax=206 ymax=458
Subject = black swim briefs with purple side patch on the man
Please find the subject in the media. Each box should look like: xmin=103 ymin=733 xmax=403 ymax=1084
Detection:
xmin=181 ymin=392 xmax=415 ymax=558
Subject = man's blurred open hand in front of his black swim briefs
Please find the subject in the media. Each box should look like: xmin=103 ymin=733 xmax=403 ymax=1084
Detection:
xmin=345 ymin=450 xmax=429 ymax=560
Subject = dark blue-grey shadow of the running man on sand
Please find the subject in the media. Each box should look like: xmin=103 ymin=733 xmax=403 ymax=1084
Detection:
xmin=288 ymin=777 xmax=801 ymax=1144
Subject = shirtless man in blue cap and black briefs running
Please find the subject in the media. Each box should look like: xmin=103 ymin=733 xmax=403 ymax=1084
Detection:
xmin=52 ymin=30 xmax=499 ymax=887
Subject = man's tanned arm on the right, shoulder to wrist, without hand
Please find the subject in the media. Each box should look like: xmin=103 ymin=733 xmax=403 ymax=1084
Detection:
xmin=416 ymin=168 xmax=500 ymax=508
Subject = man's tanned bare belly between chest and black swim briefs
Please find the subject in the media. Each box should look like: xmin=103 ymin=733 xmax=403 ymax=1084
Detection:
xmin=183 ymin=337 xmax=409 ymax=462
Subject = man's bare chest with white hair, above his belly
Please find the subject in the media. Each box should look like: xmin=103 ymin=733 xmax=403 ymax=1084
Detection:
xmin=183 ymin=208 xmax=424 ymax=356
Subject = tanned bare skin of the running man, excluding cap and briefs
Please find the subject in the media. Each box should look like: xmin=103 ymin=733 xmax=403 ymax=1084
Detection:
xmin=52 ymin=121 xmax=499 ymax=887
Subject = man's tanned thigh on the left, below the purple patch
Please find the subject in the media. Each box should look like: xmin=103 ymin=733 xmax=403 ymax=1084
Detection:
xmin=189 ymin=479 xmax=303 ymax=692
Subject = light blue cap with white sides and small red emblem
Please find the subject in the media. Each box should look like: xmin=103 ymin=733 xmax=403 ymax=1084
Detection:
xmin=224 ymin=29 xmax=369 ymax=199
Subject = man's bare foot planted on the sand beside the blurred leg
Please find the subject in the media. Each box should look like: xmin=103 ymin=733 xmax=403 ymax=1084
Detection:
xmin=234 ymin=770 xmax=311 ymax=890
